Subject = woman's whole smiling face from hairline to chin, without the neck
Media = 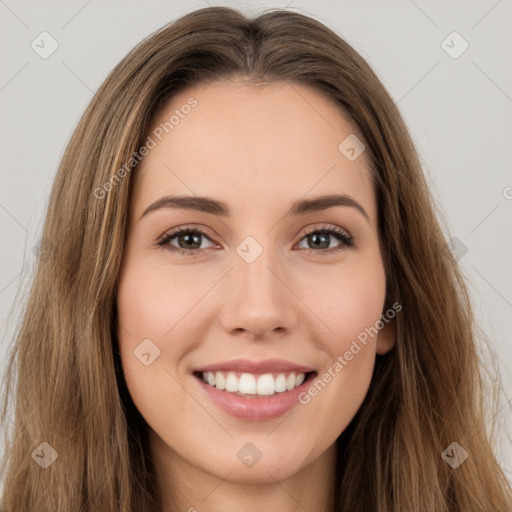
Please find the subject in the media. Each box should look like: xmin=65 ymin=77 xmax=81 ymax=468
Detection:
xmin=117 ymin=80 xmax=394 ymax=482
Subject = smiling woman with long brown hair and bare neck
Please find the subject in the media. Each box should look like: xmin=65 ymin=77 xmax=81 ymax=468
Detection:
xmin=2 ymin=7 xmax=511 ymax=512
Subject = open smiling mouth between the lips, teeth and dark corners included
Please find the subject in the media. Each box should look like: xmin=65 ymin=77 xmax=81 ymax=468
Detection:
xmin=193 ymin=370 xmax=317 ymax=398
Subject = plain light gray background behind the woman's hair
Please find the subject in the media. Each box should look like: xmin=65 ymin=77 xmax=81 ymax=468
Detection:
xmin=0 ymin=0 xmax=512 ymax=488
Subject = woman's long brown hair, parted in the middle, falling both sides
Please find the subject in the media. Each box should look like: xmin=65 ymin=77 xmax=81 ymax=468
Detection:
xmin=1 ymin=7 xmax=512 ymax=512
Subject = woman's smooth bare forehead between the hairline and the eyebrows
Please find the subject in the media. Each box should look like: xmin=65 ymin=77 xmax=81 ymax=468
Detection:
xmin=134 ymin=80 xmax=375 ymax=222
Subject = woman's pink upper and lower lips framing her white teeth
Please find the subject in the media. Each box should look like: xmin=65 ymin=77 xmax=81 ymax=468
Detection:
xmin=194 ymin=359 xmax=316 ymax=421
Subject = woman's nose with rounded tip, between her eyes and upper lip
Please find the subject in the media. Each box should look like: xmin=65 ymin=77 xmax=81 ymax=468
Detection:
xmin=220 ymin=244 xmax=300 ymax=340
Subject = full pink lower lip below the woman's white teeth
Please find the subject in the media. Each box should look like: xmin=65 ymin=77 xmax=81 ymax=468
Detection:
xmin=194 ymin=374 xmax=315 ymax=421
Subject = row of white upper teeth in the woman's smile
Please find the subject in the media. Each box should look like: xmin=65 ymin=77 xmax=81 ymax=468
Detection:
xmin=202 ymin=372 xmax=306 ymax=396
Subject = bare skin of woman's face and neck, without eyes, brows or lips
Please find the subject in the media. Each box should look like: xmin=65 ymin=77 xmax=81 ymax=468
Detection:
xmin=117 ymin=79 xmax=394 ymax=512
